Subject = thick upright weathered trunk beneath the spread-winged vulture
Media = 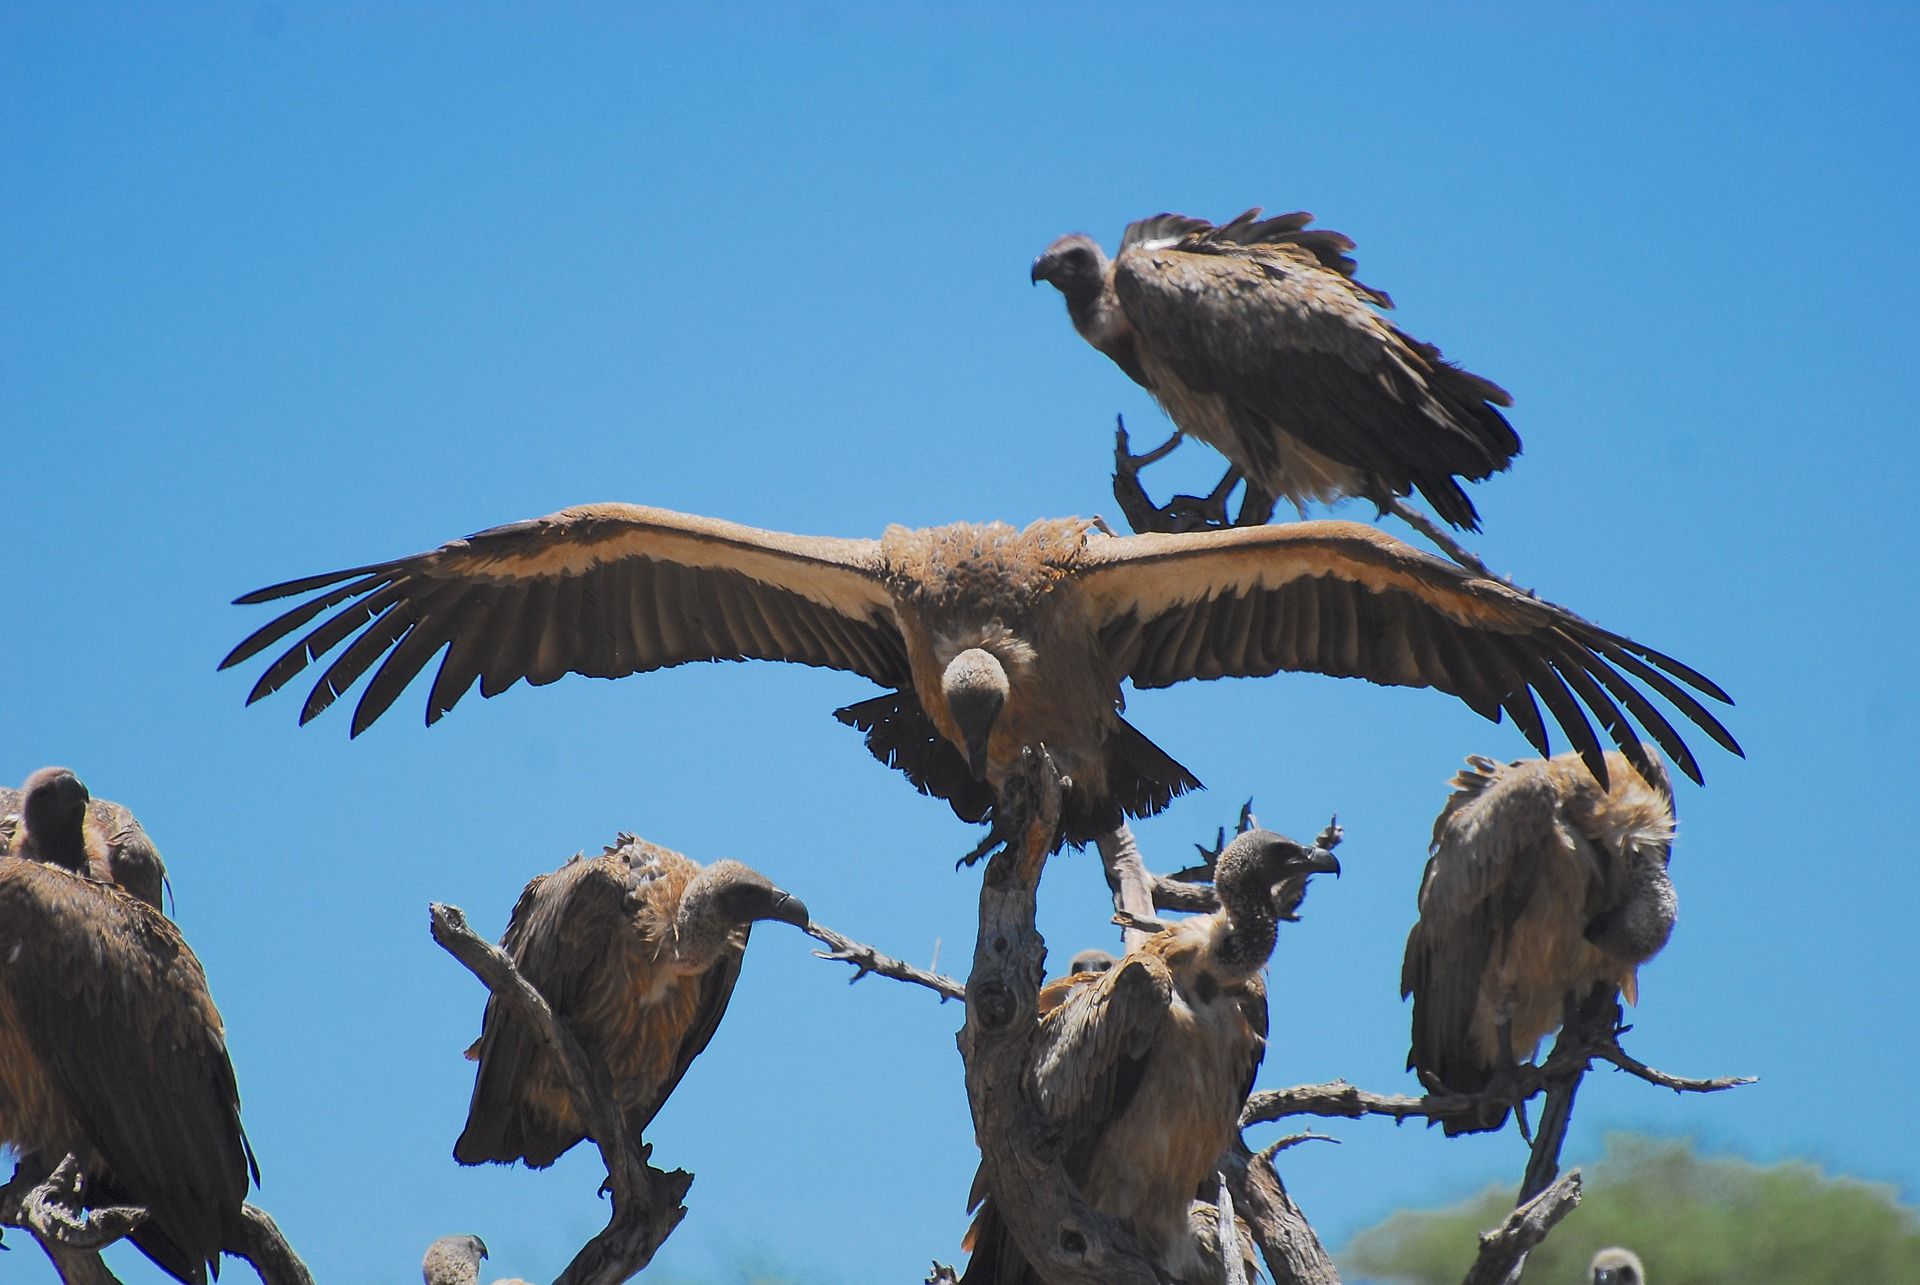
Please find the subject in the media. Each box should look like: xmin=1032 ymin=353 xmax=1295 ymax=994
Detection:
xmin=958 ymin=749 xmax=1158 ymax=1285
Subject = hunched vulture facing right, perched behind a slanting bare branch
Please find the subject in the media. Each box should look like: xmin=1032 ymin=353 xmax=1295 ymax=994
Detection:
xmin=453 ymin=836 xmax=806 ymax=1170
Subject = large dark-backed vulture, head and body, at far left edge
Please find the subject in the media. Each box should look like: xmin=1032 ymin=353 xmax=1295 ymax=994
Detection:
xmin=0 ymin=768 xmax=259 ymax=1285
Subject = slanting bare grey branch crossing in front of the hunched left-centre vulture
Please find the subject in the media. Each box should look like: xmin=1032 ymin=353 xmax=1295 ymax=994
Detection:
xmin=430 ymin=903 xmax=693 ymax=1285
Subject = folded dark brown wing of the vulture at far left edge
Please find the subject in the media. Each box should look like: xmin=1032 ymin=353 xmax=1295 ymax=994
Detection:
xmin=0 ymin=861 xmax=259 ymax=1281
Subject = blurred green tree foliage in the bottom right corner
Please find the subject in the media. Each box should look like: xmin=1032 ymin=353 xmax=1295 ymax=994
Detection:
xmin=1340 ymin=1135 xmax=1920 ymax=1285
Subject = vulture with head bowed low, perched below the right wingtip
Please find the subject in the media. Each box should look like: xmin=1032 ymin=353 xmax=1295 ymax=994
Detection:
xmin=1400 ymin=755 xmax=1678 ymax=1135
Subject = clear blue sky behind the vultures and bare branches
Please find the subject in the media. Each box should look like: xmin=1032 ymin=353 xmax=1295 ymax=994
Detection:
xmin=0 ymin=4 xmax=1920 ymax=1283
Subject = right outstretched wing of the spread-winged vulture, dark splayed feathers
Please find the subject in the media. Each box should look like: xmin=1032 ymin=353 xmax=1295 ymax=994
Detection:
xmin=1079 ymin=522 xmax=1741 ymax=782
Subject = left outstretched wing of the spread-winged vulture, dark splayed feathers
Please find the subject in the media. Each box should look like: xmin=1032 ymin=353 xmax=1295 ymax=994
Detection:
xmin=221 ymin=503 xmax=910 ymax=736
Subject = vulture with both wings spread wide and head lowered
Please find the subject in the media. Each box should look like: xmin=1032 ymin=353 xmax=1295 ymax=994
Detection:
xmin=221 ymin=503 xmax=1740 ymax=845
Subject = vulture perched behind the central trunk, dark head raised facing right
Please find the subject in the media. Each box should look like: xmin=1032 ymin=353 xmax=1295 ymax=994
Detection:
xmin=962 ymin=830 xmax=1340 ymax=1285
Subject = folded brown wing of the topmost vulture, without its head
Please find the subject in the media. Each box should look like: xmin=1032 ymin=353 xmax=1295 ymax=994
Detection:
xmin=1114 ymin=209 xmax=1521 ymax=526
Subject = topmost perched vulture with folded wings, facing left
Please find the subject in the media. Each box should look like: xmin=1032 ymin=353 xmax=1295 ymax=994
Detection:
xmin=1033 ymin=209 xmax=1521 ymax=530
